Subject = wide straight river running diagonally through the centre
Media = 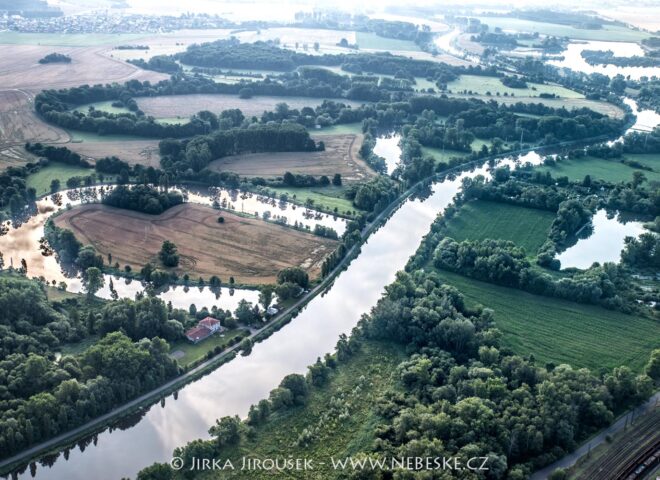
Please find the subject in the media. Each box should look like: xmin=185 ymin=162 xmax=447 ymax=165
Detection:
xmin=9 ymin=153 xmax=541 ymax=480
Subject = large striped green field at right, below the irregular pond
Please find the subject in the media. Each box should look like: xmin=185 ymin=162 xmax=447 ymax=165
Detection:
xmin=439 ymin=271 xmax=660 ymax=372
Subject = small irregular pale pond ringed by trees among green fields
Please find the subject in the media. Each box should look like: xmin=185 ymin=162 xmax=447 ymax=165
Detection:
xmin=557 ymin=210 xmax=644 ymax=268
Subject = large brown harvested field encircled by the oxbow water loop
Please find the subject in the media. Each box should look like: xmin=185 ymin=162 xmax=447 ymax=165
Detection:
xmin=55 ymin=203 xmax=337 ymax=284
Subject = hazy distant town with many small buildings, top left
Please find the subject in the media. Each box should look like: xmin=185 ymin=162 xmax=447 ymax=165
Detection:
xmin=0 ymin=11 xmax=235 ymax=33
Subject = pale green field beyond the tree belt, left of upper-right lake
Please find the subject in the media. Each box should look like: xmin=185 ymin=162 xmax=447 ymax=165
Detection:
xmin=447 ymin=75 xmax=584 ymax=98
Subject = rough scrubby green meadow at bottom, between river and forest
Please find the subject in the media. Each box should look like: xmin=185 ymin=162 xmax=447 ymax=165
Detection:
xmin=217 ymin=341 xmax=405 ymax=480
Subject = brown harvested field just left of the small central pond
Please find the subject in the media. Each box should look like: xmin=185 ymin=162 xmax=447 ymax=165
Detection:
xmin=209 ymin=134 xmax=375 ymax=183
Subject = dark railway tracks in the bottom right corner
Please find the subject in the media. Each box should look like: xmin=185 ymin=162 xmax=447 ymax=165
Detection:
xmin=580 ymin=408 xmax=660 ymax=480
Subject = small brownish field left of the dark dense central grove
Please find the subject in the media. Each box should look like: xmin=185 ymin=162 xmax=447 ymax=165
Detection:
xmin=67 ymin=140 xmax=160 ymax=168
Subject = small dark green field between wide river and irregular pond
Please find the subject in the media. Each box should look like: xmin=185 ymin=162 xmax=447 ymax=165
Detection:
xmin=446 ymin=200 xmax=555 ymax=256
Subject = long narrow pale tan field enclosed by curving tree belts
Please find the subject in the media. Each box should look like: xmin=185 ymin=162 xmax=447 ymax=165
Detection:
xmin=136 ymin=93 xmax=362 ymax=118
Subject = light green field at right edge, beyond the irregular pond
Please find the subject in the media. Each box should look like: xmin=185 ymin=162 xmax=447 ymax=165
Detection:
xmin=538 ymin=154 xmax=660 ymax=185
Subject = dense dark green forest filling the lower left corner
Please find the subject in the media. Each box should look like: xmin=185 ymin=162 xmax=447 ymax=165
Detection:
xmin=0 ymin=275 xmax=183 ymax=457
